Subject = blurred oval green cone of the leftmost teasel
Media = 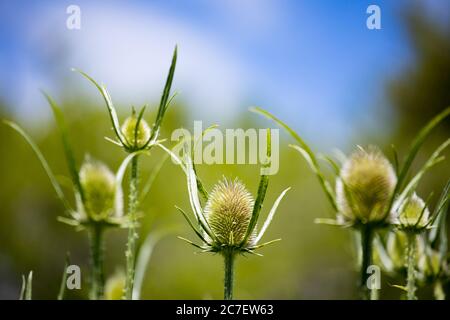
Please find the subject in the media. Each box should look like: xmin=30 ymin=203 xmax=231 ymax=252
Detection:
xmin=79 ymin=158 xmax=116 ymax=221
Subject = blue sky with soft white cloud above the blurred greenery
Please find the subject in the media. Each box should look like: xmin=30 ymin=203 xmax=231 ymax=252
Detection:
xmin=0 ymin=0 xmax=450 ymax=144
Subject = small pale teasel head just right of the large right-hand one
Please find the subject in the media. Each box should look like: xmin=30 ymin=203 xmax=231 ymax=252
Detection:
xmin=394 ymin=193 xmax=430 ymax=229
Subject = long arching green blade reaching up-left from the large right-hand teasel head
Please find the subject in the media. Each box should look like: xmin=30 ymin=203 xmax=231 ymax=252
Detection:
xmin=250 ymin=107 xmax=338 ymax=211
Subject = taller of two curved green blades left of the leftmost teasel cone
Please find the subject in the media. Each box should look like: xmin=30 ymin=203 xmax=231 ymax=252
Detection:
xmin=42 ymin=91 xmax=84 ymax=202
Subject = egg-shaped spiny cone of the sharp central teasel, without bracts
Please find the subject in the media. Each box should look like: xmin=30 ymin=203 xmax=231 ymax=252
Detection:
xmin=204 ymin=179 xmax=254 ymax=246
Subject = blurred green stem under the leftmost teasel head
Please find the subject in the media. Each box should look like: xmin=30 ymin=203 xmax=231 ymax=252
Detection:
xmin=90 ymin=224 xmax=105 ymax=300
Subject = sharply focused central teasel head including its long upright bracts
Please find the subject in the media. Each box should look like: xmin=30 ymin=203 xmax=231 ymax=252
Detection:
xmin=172 ymin=130 xmax=290 ymax=254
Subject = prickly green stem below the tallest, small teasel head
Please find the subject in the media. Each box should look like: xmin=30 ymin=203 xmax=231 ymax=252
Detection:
xmin=124 ymin=156 xmax=139 ymax=300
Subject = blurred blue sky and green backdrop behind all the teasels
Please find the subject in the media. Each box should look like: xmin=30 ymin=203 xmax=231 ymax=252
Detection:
xmin=0 ymin=0 xmax=450 ymax=299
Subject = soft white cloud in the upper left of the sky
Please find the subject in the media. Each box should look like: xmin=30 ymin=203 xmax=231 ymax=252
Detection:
xmin=17 ymin=2 xmax=248 ymax=121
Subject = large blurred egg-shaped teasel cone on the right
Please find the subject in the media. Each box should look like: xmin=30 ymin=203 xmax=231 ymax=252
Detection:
xmin=336 ymin=147 xmax=397 ymax=223
